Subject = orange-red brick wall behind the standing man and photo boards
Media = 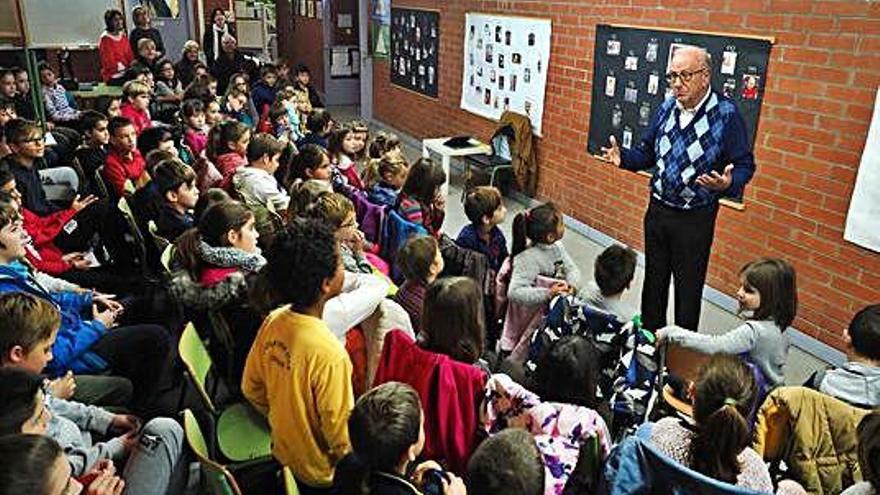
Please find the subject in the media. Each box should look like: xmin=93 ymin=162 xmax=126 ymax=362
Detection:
xmin=373 ymin=0 xmax=880 ymax=349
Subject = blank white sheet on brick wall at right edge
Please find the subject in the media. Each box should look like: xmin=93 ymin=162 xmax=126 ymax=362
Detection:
xmin=843 ymin=88 xmax=880 ymax=252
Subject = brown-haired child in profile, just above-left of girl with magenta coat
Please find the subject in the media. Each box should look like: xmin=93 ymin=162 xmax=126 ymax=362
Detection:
xmin=394 ymin=235 xmax=443 ymax=333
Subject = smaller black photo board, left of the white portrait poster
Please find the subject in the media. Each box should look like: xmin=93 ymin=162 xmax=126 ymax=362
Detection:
xmin=390 ymin=7 xmax=440 ymax=98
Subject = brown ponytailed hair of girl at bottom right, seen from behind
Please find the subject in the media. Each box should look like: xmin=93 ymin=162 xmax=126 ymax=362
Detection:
xmin=688 ymin=355 xmax=757 ymax=484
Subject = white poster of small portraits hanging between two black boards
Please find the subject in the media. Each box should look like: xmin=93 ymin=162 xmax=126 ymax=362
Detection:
xmin=461 ymin=13 xmax=551 ymax=136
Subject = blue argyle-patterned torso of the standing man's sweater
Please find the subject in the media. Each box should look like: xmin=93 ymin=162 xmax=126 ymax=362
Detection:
xmin=651 ymin=92 xmax=737 ymax=210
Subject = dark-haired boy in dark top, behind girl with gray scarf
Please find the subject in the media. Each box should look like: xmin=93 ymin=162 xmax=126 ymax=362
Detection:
xmin=153 ymin=159 xmax=199 ymax=241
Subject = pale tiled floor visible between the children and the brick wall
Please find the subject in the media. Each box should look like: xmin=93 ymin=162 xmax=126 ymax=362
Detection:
xmin=331 ymin=103 xmax=826 ymax=385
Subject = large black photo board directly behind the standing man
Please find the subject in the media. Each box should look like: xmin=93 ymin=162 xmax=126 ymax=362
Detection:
xmin=588 ymin=24 xmax=772 ymax=159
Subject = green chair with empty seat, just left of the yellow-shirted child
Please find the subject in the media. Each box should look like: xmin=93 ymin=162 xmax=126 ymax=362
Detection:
xmin=178 ymin=323 xmax=272 ymax=463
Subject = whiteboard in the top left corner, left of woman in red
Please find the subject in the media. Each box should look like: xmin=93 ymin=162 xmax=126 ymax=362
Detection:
xmin=21 ymin=0 xmax=125 ymax=48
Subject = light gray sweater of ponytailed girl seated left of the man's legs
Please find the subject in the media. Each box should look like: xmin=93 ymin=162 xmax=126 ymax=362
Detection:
xmin=507 ymin=241 xmax=581 ymax=306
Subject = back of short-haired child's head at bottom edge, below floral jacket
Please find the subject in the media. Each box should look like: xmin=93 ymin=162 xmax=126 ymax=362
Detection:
xmin=467 ymin=428 xmax=545 ymax=495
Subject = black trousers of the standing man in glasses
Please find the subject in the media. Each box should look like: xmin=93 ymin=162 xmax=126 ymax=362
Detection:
xmin=642 ymin=198 xmax=718 ymax=331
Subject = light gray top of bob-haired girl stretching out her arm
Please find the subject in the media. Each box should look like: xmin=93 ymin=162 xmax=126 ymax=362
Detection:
xmin=663 ymin=320 xmax=789 ymax=387
